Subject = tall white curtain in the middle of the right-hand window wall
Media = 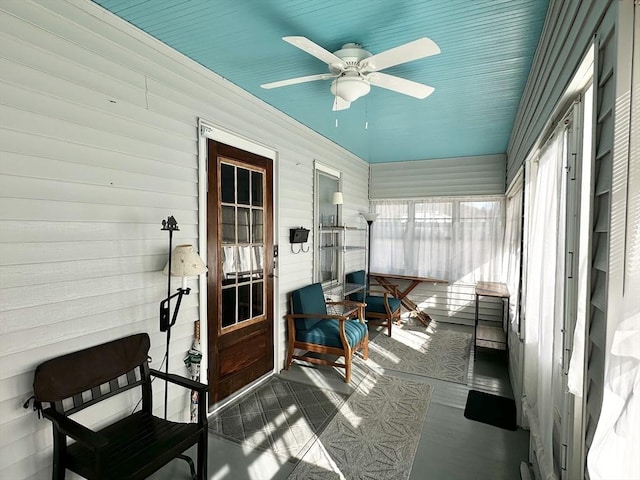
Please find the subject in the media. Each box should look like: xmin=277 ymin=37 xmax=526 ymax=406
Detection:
xmin=524 ymin=132 xmax=565 ymax=479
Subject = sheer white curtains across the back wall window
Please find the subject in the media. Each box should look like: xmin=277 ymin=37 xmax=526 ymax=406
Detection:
xmin=371 ymin=198 xmax=504 ymax=284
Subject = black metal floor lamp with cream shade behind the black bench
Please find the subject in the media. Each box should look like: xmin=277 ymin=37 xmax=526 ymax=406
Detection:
xmin=160 ymin=216 xmax=207 ymax=419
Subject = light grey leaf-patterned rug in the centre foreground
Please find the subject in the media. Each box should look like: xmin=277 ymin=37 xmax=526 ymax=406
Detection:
xmin=289 ymin=374 xmax=432 ymax=480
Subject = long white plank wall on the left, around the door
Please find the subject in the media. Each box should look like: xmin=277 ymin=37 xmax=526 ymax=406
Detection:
xmin=0 ymin=0 xmax=369 ymax=480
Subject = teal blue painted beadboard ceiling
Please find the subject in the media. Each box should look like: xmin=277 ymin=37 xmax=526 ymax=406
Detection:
xmin=94 ymin=0 xmax=548 ymax=163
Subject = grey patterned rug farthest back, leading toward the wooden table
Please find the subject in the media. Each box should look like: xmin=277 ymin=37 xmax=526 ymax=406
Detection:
xmin=360 ymin=319 xmax=472 ymax=383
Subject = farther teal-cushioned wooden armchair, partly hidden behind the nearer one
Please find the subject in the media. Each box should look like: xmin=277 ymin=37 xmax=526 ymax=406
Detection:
xmin=346 ymin=270 xmax=402 ymax=336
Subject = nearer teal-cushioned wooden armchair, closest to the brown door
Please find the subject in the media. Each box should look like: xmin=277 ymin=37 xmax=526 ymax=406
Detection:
xmin=285 ymin=283 xmax=369 ymax=383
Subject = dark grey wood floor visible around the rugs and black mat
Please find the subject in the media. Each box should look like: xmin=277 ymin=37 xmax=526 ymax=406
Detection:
xmin=153 ymin=325 xmax=529 ymax=480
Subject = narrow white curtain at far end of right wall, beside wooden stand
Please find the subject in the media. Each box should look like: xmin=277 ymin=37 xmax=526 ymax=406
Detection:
xmin=502 ymin=176 xmax=523 ymax=333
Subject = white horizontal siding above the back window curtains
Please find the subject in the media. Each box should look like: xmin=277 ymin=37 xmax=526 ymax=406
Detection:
xmin=370 ymin=155 xmax=506 ymax=199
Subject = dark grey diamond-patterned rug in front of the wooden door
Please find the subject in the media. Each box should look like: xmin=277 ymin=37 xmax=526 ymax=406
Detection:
xmin=209 ymin=377 xmax=348 ymax=463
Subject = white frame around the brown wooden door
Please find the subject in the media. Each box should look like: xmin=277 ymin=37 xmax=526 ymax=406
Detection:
xmin=198 ymin=118 xmax=284 ymax=408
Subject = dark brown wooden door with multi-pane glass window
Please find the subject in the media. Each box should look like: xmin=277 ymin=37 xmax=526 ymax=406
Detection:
xmin=207 ymin=140 xmax=273 ymax=406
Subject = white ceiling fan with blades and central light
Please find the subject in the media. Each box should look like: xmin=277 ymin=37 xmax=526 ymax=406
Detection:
xmin=261 ymin=37 xmax=440 ymax=110
